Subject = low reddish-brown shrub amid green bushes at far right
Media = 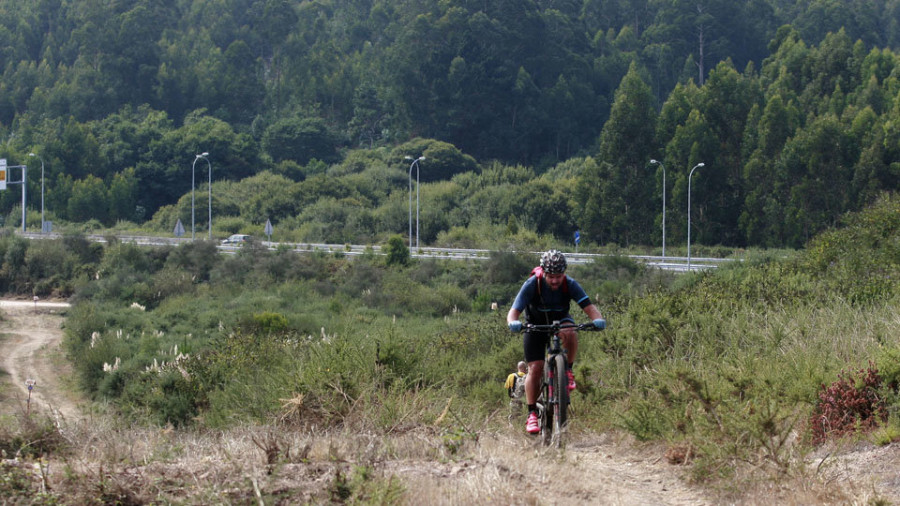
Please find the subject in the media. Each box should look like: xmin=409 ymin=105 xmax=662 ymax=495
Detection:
xmin=809 ymin=363 xmax=887 ymax=444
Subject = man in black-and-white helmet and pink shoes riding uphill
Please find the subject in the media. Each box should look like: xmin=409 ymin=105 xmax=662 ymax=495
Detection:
xmin=506 ymin=250 xmax=606 ymax=434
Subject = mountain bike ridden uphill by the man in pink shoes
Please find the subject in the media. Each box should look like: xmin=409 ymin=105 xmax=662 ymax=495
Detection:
xmin=522 ymin=321 xmax=600 ymax=448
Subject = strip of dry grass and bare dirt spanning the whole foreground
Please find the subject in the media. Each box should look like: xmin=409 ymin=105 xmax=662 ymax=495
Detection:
xmin=0 ymin=402 xmax=896 ymax=505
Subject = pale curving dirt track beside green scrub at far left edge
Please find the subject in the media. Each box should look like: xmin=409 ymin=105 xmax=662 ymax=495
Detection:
xmin=0 ymin=300 xmax=80 ymax=419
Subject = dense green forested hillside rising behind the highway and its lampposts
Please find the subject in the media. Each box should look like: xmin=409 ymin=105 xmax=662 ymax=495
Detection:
xmin=0 ymin=0 xmax=900 ymax=247
